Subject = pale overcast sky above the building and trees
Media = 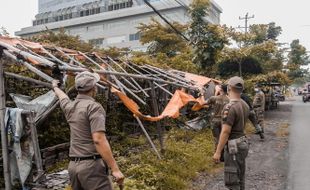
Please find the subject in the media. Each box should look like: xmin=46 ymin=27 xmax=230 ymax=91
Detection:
xmin=0 ymin=0 xmax=310 ymax=50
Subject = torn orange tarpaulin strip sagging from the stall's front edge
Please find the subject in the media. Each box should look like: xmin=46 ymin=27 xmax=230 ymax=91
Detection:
xmin=111 ymin=88 xmax=204 ymax=121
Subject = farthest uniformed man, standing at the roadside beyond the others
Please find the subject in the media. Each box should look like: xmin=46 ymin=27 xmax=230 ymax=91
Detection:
xmin=253 ymin=84 xmax=266 ymax=131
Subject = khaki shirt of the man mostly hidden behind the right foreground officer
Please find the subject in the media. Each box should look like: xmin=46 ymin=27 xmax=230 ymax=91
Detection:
xmin=206 ymin=95 xmax=229 ymax=121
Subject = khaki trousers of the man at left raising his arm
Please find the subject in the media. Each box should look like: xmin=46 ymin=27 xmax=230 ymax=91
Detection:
xmin=68 ymin=159 xmax=113 ymax=190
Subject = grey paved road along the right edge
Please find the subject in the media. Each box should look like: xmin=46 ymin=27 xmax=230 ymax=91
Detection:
xmin=287 ymin=96 xmax=310 ymax=190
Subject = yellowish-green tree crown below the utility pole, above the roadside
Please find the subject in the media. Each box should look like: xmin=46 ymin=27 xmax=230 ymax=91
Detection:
xmin=218 ymin=23 xmax=284 ymax=77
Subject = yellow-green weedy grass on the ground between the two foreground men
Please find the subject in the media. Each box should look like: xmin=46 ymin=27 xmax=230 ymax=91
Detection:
xmin=113 ymin=129 xmax=214 ymax=190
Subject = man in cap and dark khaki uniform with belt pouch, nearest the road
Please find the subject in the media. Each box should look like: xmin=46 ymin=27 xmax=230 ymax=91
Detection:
xmin=213 ymin=77 xmax=249 ymax=190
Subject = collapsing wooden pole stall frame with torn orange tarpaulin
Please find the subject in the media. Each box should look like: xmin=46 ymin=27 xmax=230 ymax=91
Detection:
xmin=0 ymin=37 xmax=220 ymax=189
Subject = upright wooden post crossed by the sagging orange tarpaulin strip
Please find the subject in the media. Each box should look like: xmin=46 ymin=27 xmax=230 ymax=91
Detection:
xmin=151 ymin=83 xmax=165 ymax=153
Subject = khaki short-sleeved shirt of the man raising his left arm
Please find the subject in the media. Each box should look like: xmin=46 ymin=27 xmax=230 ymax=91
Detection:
xmin=60 ymin=94 xmax=105 ymax=157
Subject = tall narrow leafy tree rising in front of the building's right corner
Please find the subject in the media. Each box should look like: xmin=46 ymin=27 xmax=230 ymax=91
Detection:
xmin=189 ymin=0 xmax=228 ymax=72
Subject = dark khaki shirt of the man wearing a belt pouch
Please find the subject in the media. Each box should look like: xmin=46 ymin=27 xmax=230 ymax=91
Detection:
xmin=222 ymin=100 xmax=250 ymax=140
